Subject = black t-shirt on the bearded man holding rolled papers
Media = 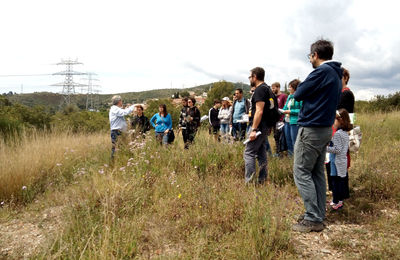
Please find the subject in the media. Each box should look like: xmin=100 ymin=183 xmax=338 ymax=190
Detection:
xmin=250 ymin=83 xmax=272 ymax=131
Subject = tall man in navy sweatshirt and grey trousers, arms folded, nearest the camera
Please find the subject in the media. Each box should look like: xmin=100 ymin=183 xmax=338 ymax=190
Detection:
xmin=293 ymin=40 xmax=342 ymax=232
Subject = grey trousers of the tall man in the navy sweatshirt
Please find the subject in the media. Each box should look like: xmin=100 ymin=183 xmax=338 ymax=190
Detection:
xmin=293 ymin=127 xmax=332 ymax=222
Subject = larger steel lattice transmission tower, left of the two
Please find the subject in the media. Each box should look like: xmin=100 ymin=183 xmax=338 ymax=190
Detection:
xmin=51 ymin=59 xmax=86 ymax=105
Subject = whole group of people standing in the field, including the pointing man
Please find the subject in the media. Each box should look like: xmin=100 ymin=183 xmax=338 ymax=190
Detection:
xmin=110 ymin=39 xmax=354 ymax=232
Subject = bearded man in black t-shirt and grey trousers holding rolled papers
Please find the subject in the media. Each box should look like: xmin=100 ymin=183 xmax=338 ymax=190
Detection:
xmin=243 ymin=67 xmax=274 ymax=184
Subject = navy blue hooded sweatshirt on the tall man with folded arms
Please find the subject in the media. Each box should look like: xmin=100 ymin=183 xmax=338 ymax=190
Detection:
xmin=294 ymin=61 xmax=342 ymax=127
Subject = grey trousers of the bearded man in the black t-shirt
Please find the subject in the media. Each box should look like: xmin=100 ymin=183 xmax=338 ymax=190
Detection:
xmin=243 ymin=128 xmax=268 ymax=184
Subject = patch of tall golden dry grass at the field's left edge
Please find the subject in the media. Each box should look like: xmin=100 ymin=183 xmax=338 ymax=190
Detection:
xmin=0 ymin=132 xmax=109 ymax=202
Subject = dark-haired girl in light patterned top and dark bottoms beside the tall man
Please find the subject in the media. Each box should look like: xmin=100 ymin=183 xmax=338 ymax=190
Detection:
xmin=327 ymin=108 xmax=353 ymax=210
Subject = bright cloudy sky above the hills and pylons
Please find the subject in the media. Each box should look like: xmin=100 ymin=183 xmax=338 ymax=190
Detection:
xmin=0 ymin=0 xmax=400 ymax=99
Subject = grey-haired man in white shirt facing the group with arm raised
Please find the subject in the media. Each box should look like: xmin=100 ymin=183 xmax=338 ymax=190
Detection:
xmin=108 ymin=95 xmax=135 ymax=160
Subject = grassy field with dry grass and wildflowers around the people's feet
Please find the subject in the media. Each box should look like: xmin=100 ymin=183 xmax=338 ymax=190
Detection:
xmin=0 ymin=112 xmax=400 ymax=259
